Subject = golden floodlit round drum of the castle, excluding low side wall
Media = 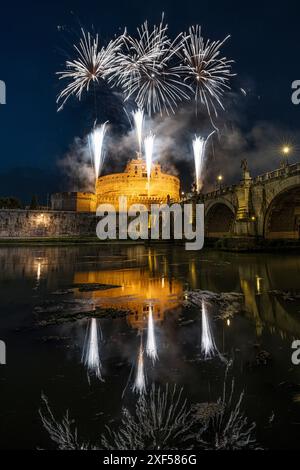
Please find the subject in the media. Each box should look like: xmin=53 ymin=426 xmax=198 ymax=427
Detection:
xmin=96 ymin=158 xmax=180 ymax=208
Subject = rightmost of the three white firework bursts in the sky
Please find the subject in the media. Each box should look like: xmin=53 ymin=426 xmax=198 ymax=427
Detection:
xmin=181 ymin=25 xmax=233 ymax=116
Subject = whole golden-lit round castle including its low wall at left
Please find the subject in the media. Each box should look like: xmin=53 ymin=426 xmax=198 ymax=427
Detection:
xmin=51 ymin=156 xmax=180 ymax=212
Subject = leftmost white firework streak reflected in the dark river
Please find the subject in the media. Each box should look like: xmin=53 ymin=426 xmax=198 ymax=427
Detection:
xmin=81 ymin=318 xmax=102 ymax=380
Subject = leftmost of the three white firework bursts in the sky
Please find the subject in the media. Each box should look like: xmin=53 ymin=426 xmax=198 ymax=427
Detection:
xmin=57 ymin=29 xmax=121 ymax=111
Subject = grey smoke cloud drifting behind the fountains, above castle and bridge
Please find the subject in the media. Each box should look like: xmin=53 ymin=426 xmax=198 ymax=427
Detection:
xmin=59 ymin=90 xmax=300 ymax=191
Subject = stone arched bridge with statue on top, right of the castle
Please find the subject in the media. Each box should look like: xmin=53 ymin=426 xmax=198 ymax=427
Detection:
xmin=196 ymin=162 xmax=300 ymax=240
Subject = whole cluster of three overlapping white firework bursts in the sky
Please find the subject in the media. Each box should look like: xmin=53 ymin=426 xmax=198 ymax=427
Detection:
xmin=57 ymin=20 xmax=233 ymax=117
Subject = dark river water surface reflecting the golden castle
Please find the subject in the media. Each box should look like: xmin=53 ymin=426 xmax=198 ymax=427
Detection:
xmin=0 ymin=245 xmax=300 ymax=448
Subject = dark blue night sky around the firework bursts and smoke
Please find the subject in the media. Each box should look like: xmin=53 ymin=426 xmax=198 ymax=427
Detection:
xmin=0 ymin=0 xmax=300 ymax=197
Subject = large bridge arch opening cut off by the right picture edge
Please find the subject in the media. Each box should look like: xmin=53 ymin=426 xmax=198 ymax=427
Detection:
xmin=264 ymin=184 xmax=300 ymax=240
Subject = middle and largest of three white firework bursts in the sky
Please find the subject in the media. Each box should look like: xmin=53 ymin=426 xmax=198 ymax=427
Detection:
xmin=113 ymin=17 xmax=189 ymax=115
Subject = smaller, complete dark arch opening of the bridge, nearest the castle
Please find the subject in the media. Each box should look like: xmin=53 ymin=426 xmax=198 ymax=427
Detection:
xmin=205 ymin=199 xmax=236 ymax=238
